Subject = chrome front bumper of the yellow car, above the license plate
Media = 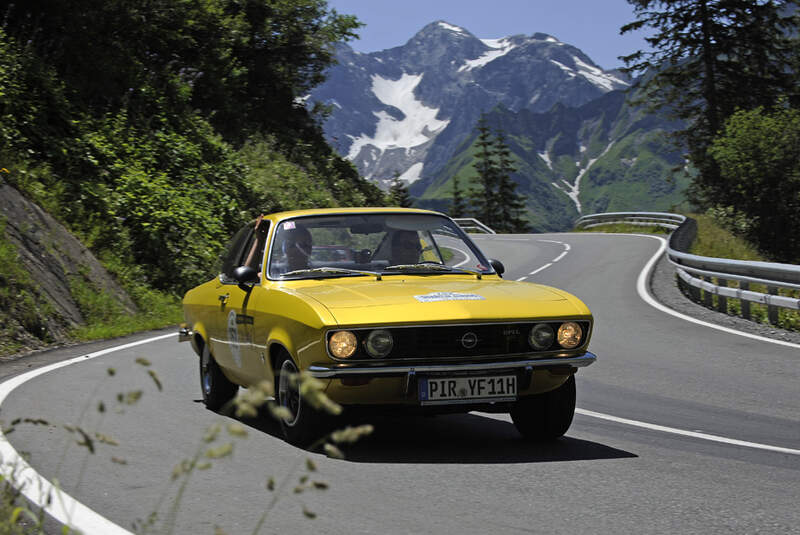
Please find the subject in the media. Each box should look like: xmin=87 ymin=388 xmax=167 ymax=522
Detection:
xmin=308 ymin=351 xmax=597 ymax=379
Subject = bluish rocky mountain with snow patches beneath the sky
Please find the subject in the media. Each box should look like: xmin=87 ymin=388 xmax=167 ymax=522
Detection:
xmin=308 ymin=21 xmax=628 ymax=190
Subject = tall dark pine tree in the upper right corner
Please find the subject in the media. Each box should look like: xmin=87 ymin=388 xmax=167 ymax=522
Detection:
xmin=620 ymin=0 xmax=797 ymax=205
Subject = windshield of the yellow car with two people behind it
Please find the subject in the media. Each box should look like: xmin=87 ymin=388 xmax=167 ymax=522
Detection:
xmin=268 ymin=213 xmax=494 ymax=279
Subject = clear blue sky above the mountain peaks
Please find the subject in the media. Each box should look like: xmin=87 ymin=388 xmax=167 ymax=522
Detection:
xmin=328 ymin=0 xmax=647 ymax=69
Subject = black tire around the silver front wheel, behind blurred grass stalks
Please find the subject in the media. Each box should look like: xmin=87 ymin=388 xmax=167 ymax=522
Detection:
xmin=275 ymin=354 xmax=334 ymax=448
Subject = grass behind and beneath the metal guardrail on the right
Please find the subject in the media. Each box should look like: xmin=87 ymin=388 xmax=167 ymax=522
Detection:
xmin=580 ymin=214 xmax=800 ymax=331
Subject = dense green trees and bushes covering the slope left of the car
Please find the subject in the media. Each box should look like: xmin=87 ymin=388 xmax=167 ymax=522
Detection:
xmin=0 ymin=0 xmax=385 ymax=302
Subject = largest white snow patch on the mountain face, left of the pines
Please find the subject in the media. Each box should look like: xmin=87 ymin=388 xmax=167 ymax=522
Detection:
xmin=347 ymin=73 xmax=450 ymax=160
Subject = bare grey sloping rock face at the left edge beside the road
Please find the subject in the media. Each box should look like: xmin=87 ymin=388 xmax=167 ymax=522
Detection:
xmin=0 ymin=183 xmax=136 ymax=354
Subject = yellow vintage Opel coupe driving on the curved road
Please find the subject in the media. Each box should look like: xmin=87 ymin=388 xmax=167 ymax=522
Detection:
xmin=181 ymin=208 xmax=596 ymax=445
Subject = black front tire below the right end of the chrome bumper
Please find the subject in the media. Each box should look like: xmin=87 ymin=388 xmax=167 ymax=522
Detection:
xmin=511 ymin=375 xmax=575 ymax=442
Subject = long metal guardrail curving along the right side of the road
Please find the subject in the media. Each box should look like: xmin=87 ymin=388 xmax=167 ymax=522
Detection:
xmin=575 ymin=212 xmax=800 ymax=323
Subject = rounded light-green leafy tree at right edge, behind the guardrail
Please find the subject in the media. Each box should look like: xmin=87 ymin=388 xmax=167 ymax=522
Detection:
xmin=710 ymin=107 xmax=800 ymax=263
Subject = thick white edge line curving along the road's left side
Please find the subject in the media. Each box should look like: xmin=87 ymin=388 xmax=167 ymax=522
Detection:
xmin=0 ymin=333 xmax=177 ymax=535
